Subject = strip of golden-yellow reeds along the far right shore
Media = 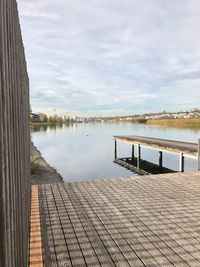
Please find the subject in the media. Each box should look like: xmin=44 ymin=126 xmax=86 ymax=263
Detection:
xmin=146 ymin=118 xmax=200 ymax=128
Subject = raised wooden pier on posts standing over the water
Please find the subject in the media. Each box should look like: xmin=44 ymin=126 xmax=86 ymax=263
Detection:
xmin=113 ymin=135 xmax=200 ymax=175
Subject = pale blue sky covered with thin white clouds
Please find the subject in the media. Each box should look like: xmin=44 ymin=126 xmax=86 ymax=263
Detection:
xmin=17 ymin=0 xmax=200 ymax=116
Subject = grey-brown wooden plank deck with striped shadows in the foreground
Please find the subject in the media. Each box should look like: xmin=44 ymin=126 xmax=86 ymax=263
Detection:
xmin=39 ymin=172 xmax=200 ymax=267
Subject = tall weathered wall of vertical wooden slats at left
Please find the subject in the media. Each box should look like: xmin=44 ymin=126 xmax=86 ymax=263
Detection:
xmin=0 ymin=0 xmax=30 ymax=267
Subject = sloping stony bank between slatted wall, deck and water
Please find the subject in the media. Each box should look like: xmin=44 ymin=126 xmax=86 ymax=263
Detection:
xmin=30 ymin=142 xmax=63 ymax=185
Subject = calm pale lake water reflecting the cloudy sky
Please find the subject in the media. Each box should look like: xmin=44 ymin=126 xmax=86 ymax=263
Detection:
xmin=32 ymin=123 xmax=200 ymax=181
